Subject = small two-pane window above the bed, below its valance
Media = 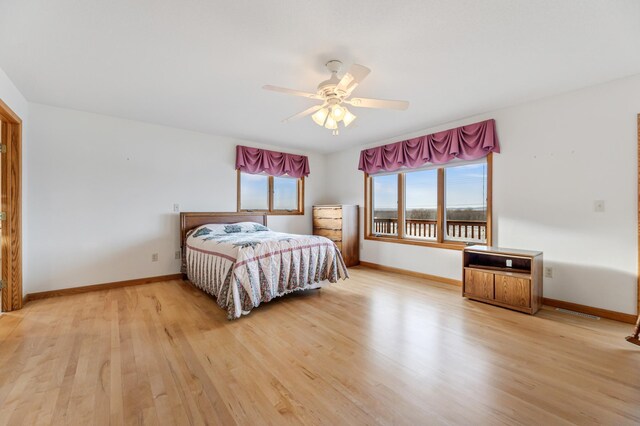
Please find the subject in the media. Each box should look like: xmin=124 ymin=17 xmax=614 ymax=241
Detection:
xmin=238 ymin=170 xmax=304 ymax=214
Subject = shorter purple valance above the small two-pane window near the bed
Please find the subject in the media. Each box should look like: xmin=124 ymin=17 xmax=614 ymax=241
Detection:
xmin=236 ymin=145 xmax=309 ymax=178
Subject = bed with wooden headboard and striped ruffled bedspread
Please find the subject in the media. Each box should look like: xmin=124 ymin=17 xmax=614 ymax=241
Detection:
xmin=180 ymin=212 xmax=349 ymax=319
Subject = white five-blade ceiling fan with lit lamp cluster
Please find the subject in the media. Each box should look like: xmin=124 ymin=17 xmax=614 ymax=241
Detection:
xmin=262 ymin=59 xmax=409 ymax=135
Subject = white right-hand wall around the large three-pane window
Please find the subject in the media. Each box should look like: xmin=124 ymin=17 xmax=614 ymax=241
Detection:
xmin=327 ymin=76 xmax=640 ymax=313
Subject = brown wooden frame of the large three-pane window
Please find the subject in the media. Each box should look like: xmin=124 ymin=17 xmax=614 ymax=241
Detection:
xmin=364 ymin=153 xmax=493 ymax=250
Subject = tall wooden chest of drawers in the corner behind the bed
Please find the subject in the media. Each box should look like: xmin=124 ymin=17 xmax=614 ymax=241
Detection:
xmin=313 ymin=204 xmax=360 ymax=266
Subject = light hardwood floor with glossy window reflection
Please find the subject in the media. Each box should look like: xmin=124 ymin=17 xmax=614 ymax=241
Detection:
xmin=0 ymin=268 xmax=640 ymax=425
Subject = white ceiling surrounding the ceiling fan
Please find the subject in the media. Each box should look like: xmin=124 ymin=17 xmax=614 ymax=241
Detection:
xmin=0 ymin=0 xmax=640 ymax=152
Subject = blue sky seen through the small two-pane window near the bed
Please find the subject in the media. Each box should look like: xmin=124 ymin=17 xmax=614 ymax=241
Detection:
xmin=240 ymin=173 xmax=298 ymax=210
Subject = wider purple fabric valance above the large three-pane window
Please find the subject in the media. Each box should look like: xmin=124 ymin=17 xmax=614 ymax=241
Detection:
xmin=358 ymin=119 xmax=500 ymax=174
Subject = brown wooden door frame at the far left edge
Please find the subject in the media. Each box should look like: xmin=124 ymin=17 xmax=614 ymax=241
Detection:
xmin=0 ymin=99 xmax=23 ymax=312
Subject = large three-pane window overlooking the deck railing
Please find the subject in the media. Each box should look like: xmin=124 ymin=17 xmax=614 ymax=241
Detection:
xmin=365 ymin=154 xmax=492 ymax=249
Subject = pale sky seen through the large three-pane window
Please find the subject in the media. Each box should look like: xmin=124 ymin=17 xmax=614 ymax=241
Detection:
xmin=373 ymin=163 xmax=487 ymax=209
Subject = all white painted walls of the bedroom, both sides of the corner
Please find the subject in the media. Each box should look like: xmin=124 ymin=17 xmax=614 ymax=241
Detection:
xmin=16 ymin=73 xmax=640 ymax=313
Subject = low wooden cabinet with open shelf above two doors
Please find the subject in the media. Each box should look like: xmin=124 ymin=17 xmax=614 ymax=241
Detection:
xmin=462 ymin=246 xmax=542 ymax=314
